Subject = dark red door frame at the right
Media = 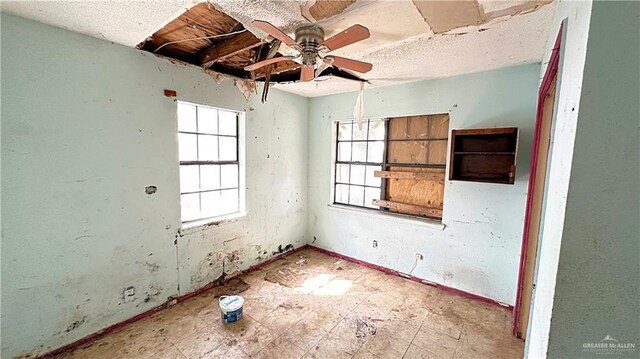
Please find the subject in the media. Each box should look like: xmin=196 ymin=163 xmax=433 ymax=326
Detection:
xmin=513 ymin=23 xmax=564 ymax=336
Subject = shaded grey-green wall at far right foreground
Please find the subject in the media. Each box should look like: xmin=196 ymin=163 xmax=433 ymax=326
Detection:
xmin=547 ymin=1 xmax=640 ymax=358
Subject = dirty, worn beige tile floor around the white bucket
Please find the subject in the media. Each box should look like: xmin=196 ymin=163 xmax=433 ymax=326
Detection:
xmin=57 ymin=249 xmax=524 ymax=359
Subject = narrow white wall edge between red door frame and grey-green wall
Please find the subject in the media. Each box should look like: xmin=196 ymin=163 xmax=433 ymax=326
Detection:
xmin=522 ymin=0 xmax=592 ymax=358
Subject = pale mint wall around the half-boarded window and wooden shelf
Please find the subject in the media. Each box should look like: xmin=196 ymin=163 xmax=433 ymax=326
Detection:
xmin=308 ymin=64 xmax=540 ymax=305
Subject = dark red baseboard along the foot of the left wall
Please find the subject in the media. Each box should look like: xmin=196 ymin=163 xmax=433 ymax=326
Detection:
xmin=35 ymin=244 xmax=309 ymax=359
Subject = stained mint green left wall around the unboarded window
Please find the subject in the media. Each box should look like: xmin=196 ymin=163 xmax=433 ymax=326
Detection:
xmin=1 ymin=13 xmax=308 ymax=358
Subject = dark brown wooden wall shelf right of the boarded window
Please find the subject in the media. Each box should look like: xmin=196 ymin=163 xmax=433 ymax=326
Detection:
xmin=449 ymin=127 xmax=518 ymax=184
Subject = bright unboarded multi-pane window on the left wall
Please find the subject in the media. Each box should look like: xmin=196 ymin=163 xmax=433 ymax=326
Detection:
xmin=178 ymin=101 xmax=242 ymax=223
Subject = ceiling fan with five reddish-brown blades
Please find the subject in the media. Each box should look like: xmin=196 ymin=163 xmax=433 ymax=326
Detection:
xmin=244 ymin=20 xmax=373 ymax=81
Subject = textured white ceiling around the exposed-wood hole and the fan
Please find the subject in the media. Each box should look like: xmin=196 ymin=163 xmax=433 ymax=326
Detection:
xmin=2 ymin=0 xmax=555 ymax=97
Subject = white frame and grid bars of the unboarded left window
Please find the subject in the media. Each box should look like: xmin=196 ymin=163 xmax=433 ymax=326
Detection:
xmin=176 ymin=100 xmax=246 ymax=229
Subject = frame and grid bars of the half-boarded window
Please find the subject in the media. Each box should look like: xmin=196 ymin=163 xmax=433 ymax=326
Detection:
xmin=331 ymin=114 xmax=451 ymax=223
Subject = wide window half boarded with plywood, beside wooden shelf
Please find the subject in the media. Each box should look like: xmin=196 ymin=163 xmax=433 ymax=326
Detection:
xmin=333 ymin=114 xmax=449 ymax=219
